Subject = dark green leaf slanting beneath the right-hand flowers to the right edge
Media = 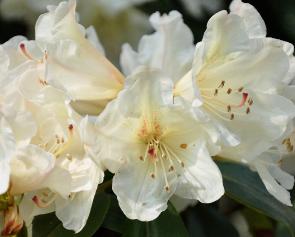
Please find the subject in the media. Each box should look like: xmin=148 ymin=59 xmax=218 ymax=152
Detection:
xmin=217 ymin=161 xmax=295 ymax=236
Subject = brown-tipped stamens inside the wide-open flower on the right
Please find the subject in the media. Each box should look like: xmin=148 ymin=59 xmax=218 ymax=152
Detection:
xmin=200 ymin=81 xmax=254 ymax=121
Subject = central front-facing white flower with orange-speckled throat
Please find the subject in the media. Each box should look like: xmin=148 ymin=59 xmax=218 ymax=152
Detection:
xmin=96 ymin=68 xmax=224 ymax=221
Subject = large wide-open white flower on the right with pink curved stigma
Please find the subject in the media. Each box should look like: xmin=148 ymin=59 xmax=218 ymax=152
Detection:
xmin=176 ymin=0 xmax=295 ymax=162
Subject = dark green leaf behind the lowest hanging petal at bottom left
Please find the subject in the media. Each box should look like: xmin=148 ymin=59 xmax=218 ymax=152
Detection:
xmin=33 ymin=193 xmax=111 ymax=237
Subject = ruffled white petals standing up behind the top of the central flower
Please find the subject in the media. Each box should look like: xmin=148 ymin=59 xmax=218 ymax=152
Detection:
xmin=121 ymin=11 xmax=194 ymax=81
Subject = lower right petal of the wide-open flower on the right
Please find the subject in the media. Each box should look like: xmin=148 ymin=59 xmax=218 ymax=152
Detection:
xmin=220 ymin=93 xmax=295 ymax=161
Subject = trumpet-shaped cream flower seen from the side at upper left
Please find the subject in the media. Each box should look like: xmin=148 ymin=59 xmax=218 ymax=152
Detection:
xmin=36 ymin=0 xmax=124 ymax=114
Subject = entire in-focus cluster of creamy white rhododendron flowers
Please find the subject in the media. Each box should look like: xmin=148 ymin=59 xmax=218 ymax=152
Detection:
xmin=0 ymin=0 xmax=295 ymax=236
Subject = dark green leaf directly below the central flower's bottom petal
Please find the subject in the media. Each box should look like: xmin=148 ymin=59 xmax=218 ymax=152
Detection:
xmin=123 ymin=204 xmax=188 ymax=237
